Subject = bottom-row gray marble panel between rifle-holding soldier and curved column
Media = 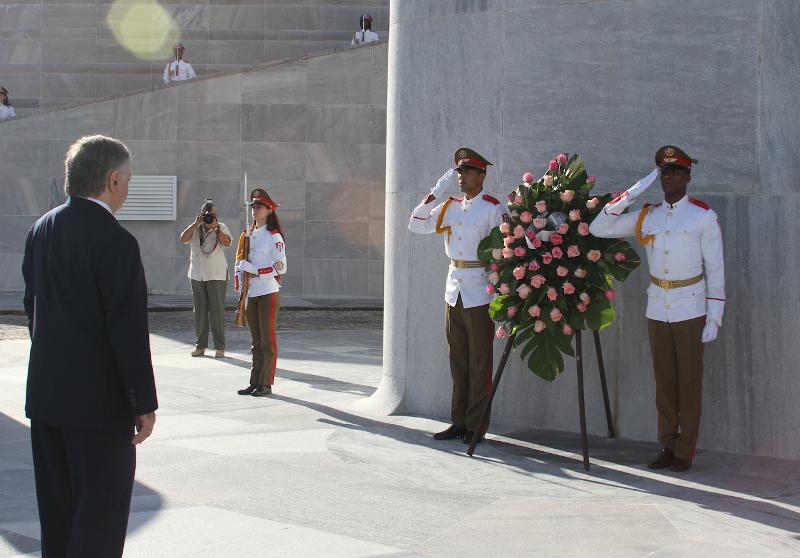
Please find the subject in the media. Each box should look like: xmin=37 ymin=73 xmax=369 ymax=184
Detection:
xmin=303 ymin=259 xmax=368 ymax=298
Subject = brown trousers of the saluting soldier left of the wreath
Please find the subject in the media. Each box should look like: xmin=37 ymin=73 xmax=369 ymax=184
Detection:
xmin=445 ymin=296 xmax=494 ymax=434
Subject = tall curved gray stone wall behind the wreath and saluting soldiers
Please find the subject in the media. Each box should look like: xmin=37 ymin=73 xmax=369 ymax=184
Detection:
xmin=374 ymin=0 xmax=800 ymax=459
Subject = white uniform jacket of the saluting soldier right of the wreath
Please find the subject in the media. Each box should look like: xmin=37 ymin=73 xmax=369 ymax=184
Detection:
xmin=589 ymin=196 xmax=725 ymax=326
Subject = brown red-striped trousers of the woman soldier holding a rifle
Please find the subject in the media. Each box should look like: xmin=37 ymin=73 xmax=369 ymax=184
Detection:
xmin=245 ymin=293 xmax=281 ymax=386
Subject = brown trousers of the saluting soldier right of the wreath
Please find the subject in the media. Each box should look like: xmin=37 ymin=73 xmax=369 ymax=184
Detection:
xmin=647 ymin=316 xmax=706 ymax=459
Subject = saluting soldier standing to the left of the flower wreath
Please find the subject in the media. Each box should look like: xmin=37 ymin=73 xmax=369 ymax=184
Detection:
xmin=408 ymin=147 xmax=508 ymax=444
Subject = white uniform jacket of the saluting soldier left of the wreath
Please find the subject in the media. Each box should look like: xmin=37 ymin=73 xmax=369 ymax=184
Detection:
xmin=408 ymin=192 xmax=508 ymax=308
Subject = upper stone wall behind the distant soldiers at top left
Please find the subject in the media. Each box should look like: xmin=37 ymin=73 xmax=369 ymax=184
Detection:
xmin=0 ymin=0 xmax=389 ymax=114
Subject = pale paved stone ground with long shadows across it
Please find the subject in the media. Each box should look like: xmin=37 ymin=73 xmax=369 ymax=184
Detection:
xmin=0 ymin=312 xmax=800 ymax=558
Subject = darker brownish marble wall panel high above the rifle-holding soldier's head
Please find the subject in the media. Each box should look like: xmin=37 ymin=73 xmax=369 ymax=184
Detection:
xmin=241 ymin=105 xmax=306 ymax=142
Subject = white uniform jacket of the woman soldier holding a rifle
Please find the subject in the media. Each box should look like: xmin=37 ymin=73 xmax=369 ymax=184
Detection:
xmin=236 ymin=225 xmax=286 ymax=298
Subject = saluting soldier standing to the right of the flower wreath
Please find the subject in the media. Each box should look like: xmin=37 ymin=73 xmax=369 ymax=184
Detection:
xmin=589 ymin=145 xmax=725 ymax=472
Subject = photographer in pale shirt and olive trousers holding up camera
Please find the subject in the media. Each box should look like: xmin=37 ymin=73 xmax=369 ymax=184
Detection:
xmin=181 ymin=199 xmax=231 ymax=358
